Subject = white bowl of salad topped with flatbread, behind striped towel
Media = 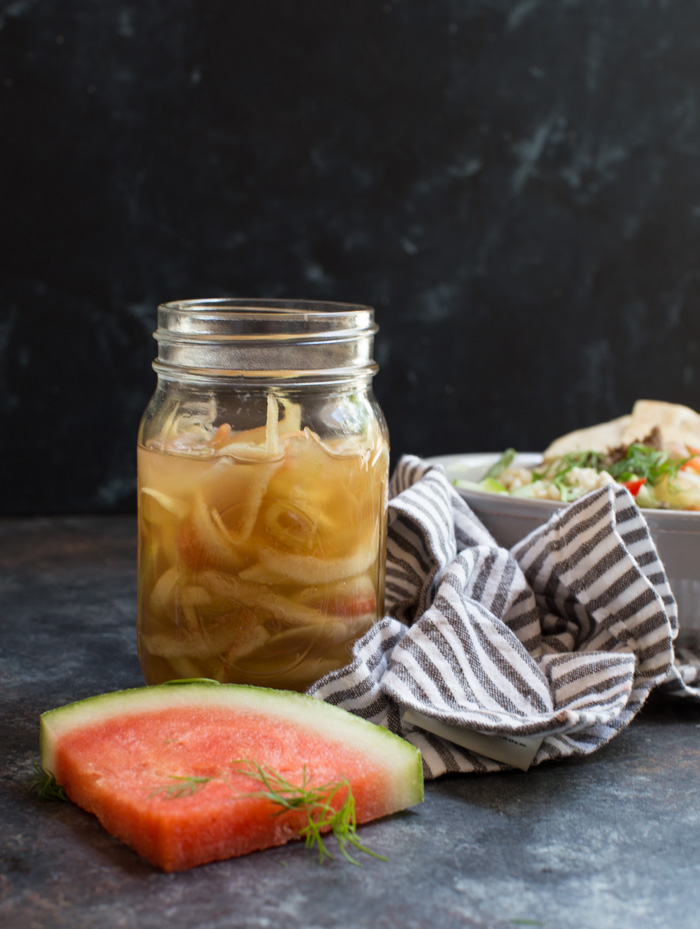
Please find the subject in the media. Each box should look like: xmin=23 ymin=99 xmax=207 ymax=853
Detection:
xmin=430 ymin=400 xmax=700 ymax=647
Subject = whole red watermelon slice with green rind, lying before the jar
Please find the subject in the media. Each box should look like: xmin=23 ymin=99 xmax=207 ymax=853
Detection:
xmin=41 ymin=681 xmax=423 ymax=871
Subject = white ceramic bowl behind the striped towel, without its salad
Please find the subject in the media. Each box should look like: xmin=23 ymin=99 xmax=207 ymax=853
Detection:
xmin=429 ymin=452 xmax=700 ymax=646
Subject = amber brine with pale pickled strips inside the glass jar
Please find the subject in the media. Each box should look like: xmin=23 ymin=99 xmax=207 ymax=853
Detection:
xmin=138 ymin=402 xmax=388 ymax=690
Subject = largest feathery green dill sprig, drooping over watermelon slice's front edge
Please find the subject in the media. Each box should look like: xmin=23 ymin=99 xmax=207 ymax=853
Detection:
xmin=232 ymin=758 xmax=387 ymax=866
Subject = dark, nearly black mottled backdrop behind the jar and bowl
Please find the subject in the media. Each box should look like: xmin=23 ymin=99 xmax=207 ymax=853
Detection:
xmin=0 ymin=0 xmax=700 ymax=513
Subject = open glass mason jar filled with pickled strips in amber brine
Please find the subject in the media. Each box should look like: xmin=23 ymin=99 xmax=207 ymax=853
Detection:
xmin=138 ymin=299 xmax=389 ymax=690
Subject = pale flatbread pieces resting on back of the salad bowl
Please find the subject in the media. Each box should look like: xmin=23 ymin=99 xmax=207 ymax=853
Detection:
xmin=544 ymin=400 xmax=700 ymax=460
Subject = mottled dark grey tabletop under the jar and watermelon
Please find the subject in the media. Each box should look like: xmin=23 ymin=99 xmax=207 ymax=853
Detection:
xmin=0 ymin=517 xmax=700 ymax=929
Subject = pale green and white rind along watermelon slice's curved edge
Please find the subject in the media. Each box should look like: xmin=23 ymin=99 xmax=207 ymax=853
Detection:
xmin=40 ymin=680 xmax=424 ymax=809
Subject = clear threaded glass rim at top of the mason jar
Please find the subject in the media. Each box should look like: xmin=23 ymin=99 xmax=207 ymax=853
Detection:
xmin=153 ymin=297 xmax=379 ymax=383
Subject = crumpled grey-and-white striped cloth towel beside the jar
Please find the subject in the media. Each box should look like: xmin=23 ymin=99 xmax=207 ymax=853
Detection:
xmin=309 ymin=456 xmax=700 ymax=778
